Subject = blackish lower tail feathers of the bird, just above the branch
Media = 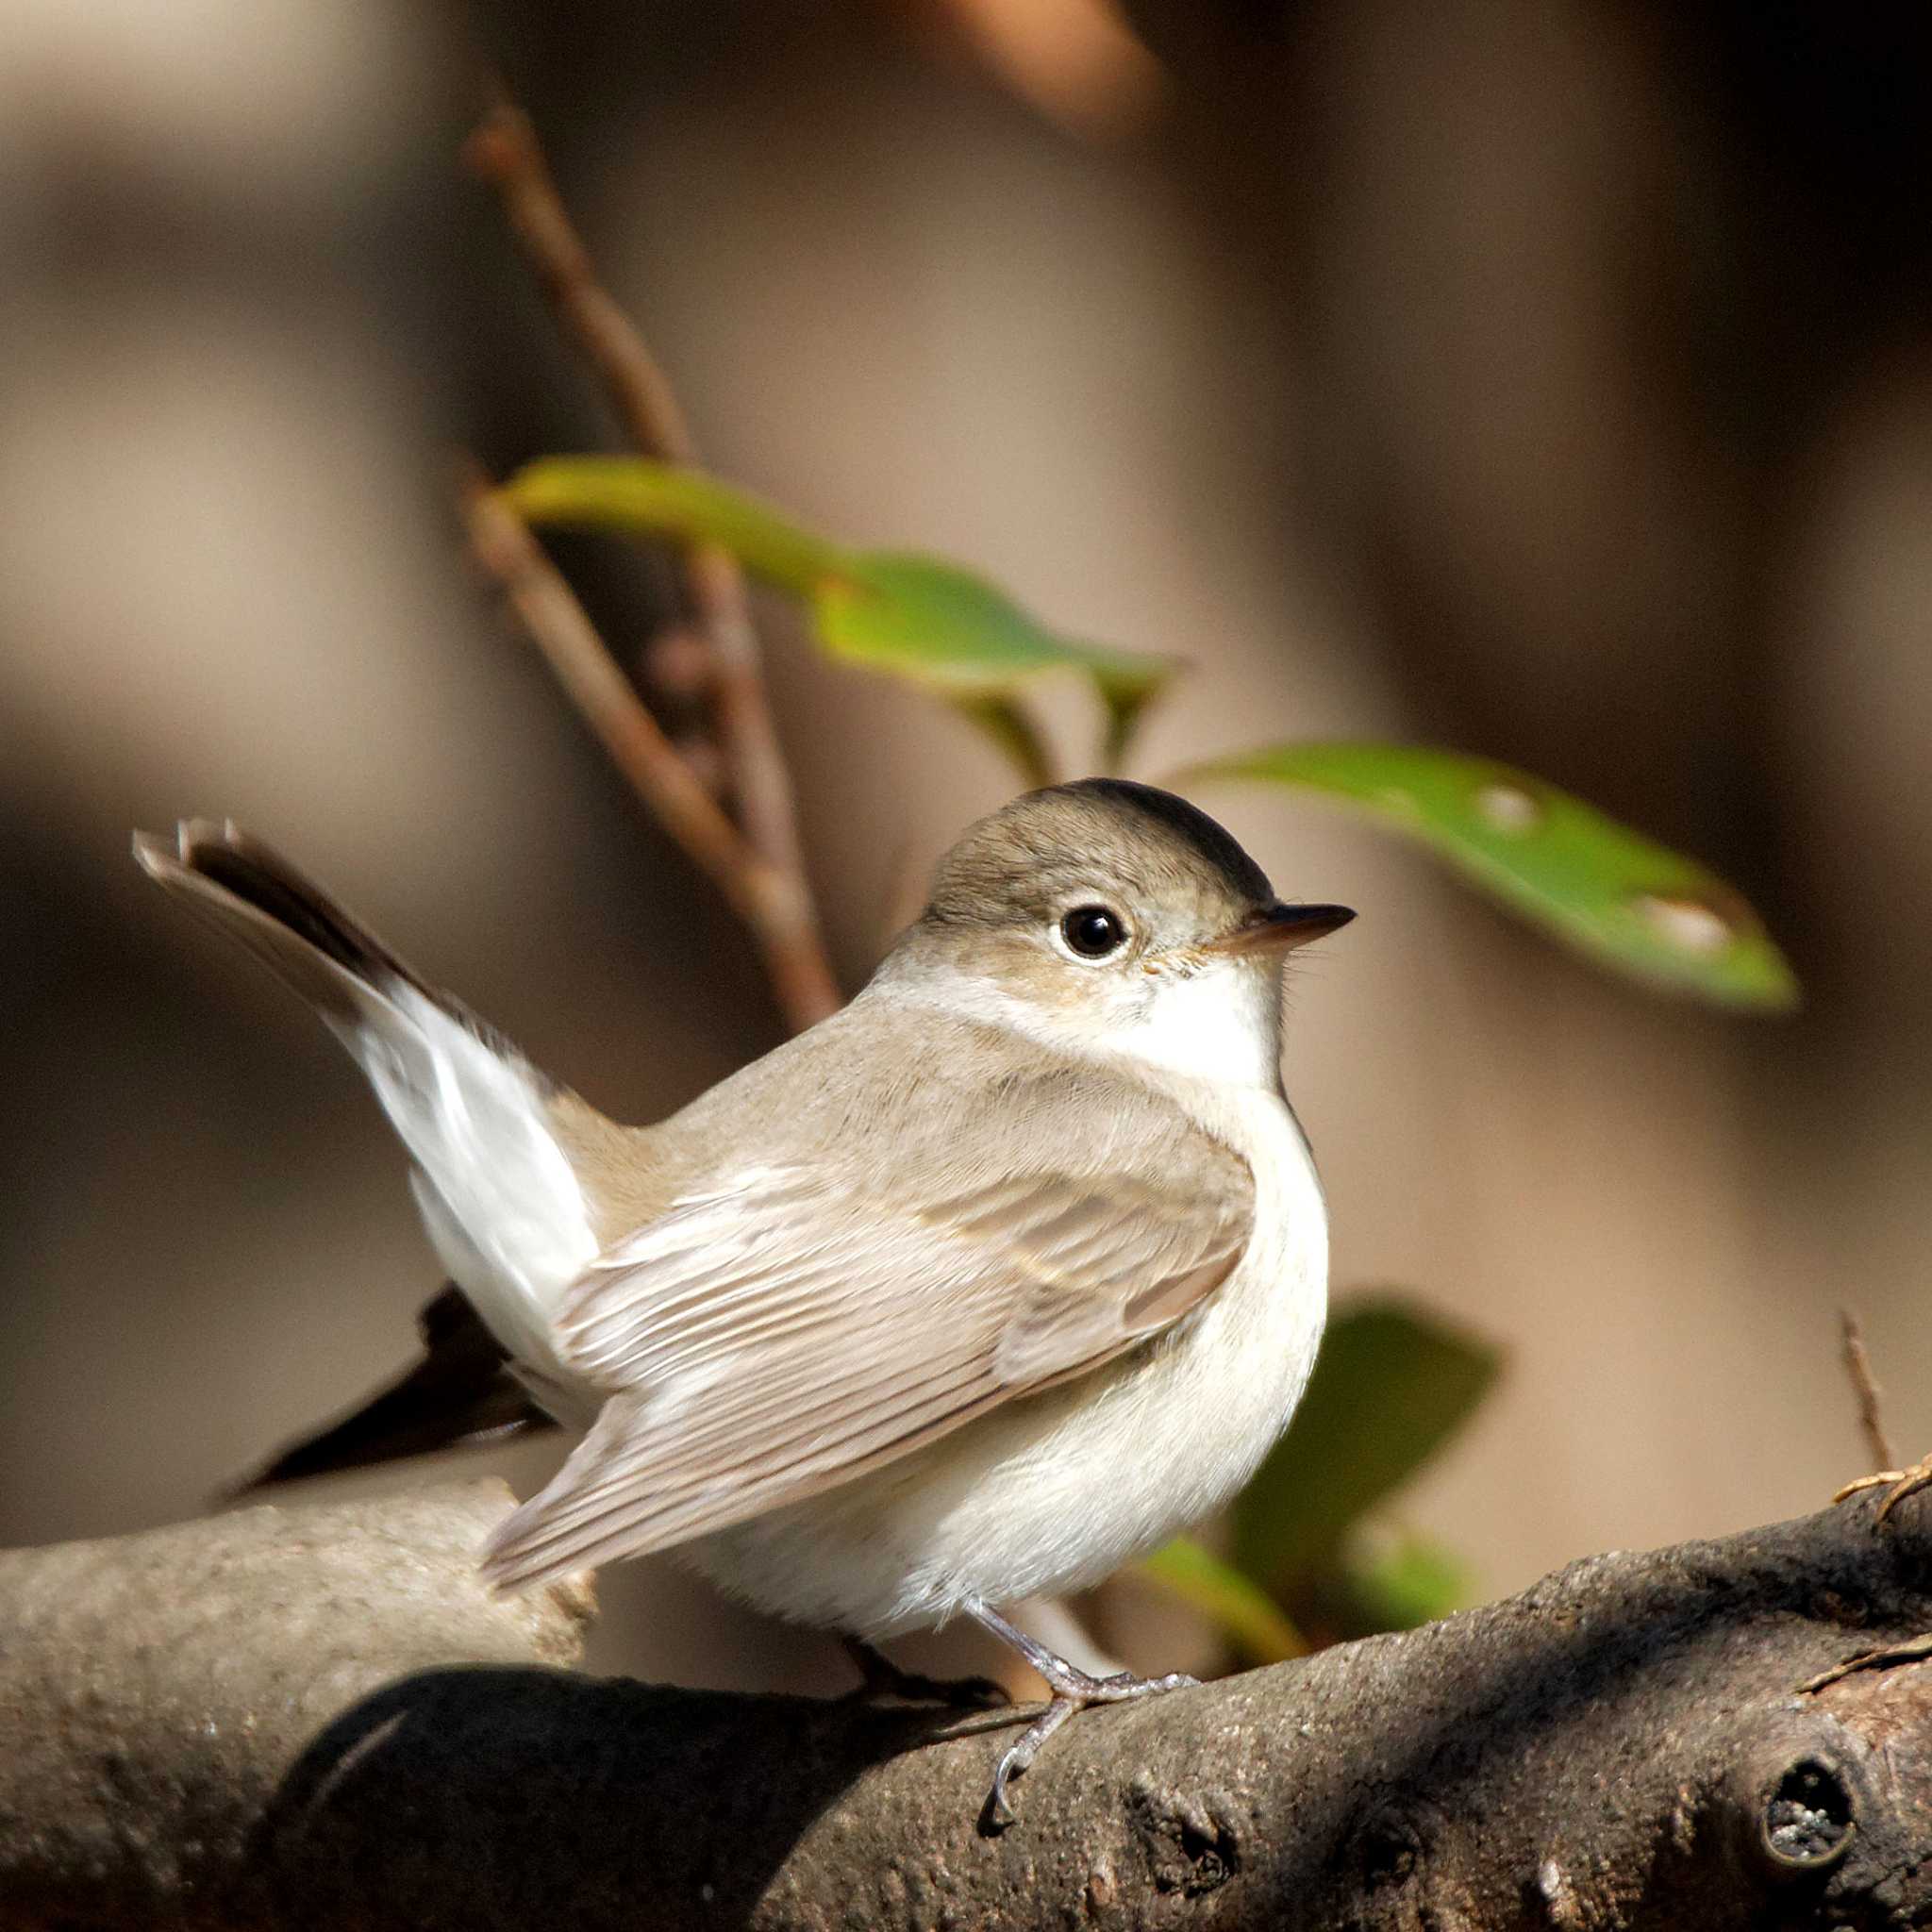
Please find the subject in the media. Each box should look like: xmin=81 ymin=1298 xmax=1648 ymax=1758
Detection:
xmin=228 ymin=1285 xmax=557 ymax=1499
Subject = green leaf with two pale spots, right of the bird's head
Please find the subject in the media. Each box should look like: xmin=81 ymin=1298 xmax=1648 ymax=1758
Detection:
xmin=1182 ymin=743 xmax=1799 ymax=1008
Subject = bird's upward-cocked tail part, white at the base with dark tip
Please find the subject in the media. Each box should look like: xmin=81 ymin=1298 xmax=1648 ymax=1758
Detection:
xmin=133 ymin=819 xmax=597 ymax=1364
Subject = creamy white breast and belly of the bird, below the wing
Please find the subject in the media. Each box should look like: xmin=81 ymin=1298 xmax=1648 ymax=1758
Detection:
xmin=686 ymin=1101 xmax=1327 ymax=1637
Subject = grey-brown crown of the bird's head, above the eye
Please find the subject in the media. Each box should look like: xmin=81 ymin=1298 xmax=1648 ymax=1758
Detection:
xmin=927 ymin=778 xmax=1275 ymax=924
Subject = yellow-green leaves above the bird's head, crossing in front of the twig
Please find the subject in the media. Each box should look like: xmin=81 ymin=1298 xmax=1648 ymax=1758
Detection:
xmin=502 ymin=456 xmax=1176 ymax=778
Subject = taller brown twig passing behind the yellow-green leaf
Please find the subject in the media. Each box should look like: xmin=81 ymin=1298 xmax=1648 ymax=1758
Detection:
xmin=464 ymin=100 xmax=841 ymax=1024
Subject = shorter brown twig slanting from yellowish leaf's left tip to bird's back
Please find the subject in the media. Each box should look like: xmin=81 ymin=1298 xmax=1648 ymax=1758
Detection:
xmin=461 ymin=470 xmax=839 ymax=1032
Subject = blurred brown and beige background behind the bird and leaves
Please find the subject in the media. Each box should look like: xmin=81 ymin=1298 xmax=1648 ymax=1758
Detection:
xmin=0 ymin=0 xmax=1932 ymax=1685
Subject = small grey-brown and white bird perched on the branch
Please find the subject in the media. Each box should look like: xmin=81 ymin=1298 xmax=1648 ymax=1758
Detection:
xmin=135 ymin=778 xmax=1353 ymax=1827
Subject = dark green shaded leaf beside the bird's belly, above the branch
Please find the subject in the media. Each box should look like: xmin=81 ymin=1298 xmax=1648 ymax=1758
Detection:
xmin=1235 ymin=1298 xmax=1501 ymax=1582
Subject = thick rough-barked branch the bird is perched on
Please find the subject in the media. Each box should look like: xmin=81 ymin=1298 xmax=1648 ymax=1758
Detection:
xmin=0 ymin=1484 xmax=1932 ymax=1932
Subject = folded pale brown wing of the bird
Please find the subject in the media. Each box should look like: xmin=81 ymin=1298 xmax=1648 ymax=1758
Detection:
xmin=485 ymin=1108 xmax=1254 ymax=1588
